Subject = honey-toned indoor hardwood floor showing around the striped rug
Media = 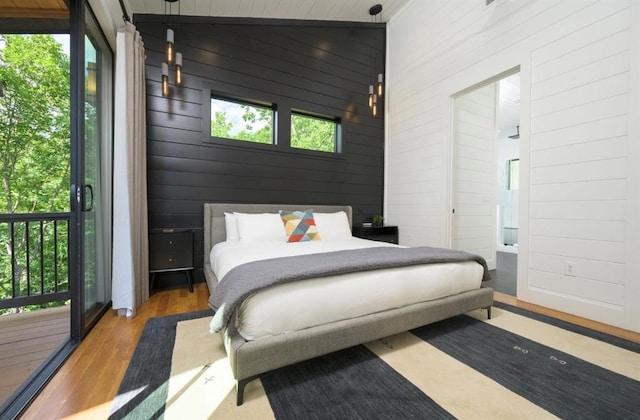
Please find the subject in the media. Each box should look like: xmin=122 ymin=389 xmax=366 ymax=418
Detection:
xmin=23 ymin=284 xmax=640 ymax=419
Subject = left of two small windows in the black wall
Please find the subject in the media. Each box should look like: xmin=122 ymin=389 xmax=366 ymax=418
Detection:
xmin=211 ymin=97 xmax=274 ymax=144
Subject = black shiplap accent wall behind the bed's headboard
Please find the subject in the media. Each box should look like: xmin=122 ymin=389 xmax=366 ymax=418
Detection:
xmin=135 ymin=15 xmax=385 ymax=279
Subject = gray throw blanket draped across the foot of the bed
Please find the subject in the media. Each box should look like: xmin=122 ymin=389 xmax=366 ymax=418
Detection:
xmin=210 ymin=246 xmax=490 ymax=332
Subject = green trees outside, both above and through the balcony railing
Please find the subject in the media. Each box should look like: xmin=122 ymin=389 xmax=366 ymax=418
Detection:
xmin=0 ymin=35 xmax=70 ymax=314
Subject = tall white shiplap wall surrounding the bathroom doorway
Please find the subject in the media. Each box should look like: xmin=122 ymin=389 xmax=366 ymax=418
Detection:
xmin=385 ymin=0 xmax=640 ymax=331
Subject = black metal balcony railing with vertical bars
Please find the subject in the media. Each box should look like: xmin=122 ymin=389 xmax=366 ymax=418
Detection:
xmin=0 ymin=213 xmax=70 ymax=313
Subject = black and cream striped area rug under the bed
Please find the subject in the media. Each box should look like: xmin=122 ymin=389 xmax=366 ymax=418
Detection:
xmin=112 ymin=304 xmax=640 ymax=419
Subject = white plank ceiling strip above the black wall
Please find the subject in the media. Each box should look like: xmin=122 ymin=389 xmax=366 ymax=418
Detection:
xmin=121 ymin=0 xmax=409 ymax=22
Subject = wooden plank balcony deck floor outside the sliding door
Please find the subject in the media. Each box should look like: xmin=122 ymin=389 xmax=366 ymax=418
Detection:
xmin=0 ymin=306 xmax=71 ymax=404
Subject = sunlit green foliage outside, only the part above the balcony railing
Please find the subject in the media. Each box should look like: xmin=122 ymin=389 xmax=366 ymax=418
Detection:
xmin=0 ymin=35 xmax=70 ymax=213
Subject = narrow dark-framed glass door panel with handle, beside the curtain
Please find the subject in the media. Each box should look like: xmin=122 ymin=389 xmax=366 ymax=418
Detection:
xmin=76 ymin=5 xmax=113 ymax=336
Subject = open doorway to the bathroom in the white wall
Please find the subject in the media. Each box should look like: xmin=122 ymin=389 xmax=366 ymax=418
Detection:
xmin=451 ymin=69 xmax=520 ymax=295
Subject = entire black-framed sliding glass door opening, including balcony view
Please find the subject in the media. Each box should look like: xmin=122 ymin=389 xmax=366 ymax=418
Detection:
xmin=0 ymin=0 xmax=113 ymax=418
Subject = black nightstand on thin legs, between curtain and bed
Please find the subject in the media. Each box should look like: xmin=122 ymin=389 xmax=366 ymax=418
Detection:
xmin=149 ymin=229 xmax=193 ymax=292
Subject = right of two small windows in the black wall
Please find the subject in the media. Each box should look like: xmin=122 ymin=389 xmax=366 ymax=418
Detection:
xmin=291 ymin=113 xmax=339 ymax=153
